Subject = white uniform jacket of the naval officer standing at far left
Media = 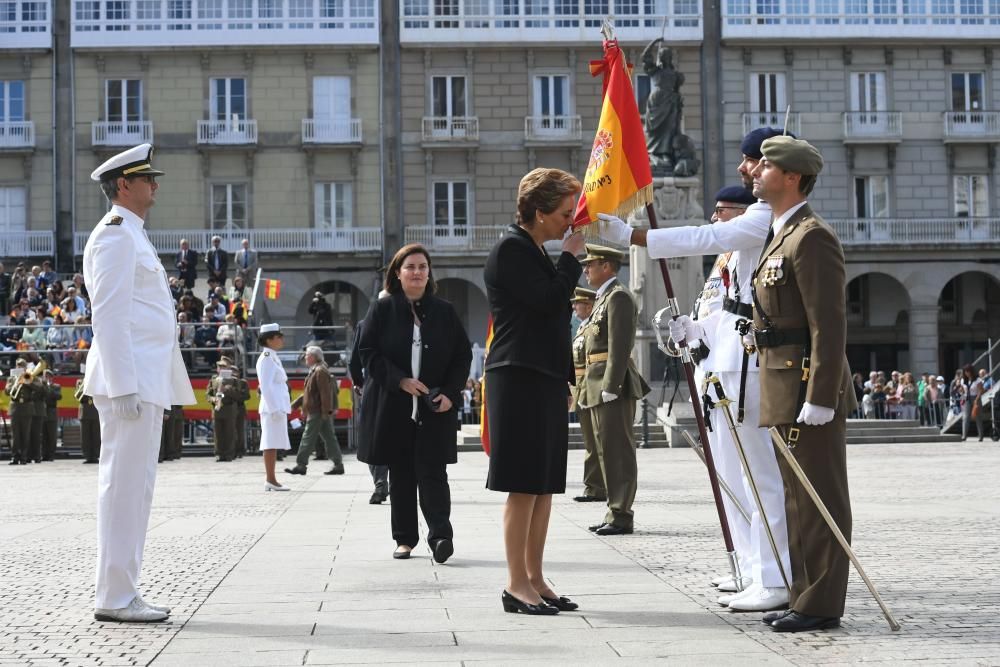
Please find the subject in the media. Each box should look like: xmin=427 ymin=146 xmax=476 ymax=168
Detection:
xmin=83 ymin=206 xmax=195 ymax=408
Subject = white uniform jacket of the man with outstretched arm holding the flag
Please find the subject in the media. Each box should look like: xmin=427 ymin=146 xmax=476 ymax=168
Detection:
xmin=646 ymin=202 xmax=771 ymax=373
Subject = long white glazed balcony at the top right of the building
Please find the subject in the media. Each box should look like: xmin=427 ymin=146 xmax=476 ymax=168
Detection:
xmin=722 ymin=0 xmax=1000 ymax=41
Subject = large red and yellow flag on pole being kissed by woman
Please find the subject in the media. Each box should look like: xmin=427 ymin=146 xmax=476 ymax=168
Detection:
xmin=573 ymin=40 xmax=653 ymax=230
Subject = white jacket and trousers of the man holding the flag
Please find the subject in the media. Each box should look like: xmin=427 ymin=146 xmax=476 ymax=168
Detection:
xmin=646 ymin=202 xmax=792 ymax=588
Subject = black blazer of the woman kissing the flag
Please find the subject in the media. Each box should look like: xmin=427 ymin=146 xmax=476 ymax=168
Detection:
xmin=484 ymin=225 xmax=583 ymax=383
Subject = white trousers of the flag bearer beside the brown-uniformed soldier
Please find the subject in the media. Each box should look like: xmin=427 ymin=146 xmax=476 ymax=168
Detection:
xmin=712 ymin=372 xmax=792 ymax=588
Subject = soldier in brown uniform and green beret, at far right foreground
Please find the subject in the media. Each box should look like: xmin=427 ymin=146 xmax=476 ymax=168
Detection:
xmin=745 ymin=137 xmax=857 ymax=632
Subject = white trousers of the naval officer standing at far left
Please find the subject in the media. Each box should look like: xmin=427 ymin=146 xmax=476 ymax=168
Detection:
xmin=94 ymin=396 xmax=163 ymax=609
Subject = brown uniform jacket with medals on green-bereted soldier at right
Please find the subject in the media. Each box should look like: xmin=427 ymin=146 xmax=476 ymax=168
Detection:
xmin=753 ymin=204 xmax=857 ymax=426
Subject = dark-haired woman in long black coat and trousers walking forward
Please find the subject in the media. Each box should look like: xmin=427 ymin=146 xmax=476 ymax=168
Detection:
xmin=358 ymin=244 xmax=472 ymax=563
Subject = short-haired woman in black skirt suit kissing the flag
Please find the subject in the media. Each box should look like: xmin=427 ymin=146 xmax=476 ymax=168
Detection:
xmin=485 ymin=169 xmax=584 ymax=614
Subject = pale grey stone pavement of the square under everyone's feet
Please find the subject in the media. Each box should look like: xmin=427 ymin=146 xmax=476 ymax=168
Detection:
xmin=0 ymin=443 xmax=1000 ymax=666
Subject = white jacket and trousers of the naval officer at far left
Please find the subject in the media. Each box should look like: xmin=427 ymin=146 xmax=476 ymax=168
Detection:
xmin=83 ymin=205 xmax=195 ymax=609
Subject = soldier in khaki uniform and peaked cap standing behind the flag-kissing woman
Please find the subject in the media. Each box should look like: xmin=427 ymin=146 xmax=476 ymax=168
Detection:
xmin=577 ymin=244 xmax=649 ymax=535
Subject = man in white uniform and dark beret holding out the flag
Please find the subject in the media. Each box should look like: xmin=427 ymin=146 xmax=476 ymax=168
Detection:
xmin=599 ymin=127 xmax=791 ymax=611
